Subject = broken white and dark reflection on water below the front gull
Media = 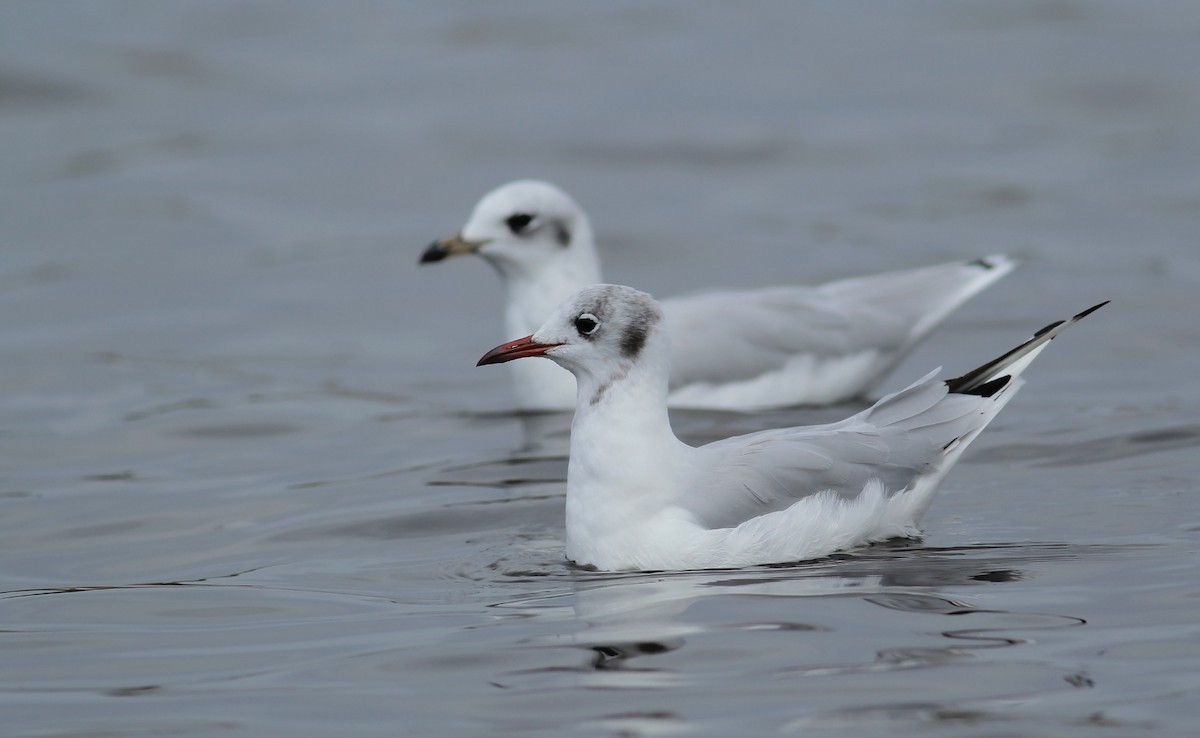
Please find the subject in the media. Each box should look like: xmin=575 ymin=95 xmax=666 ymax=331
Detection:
xmin=480 ymin=542 xmax=1126 ymax=689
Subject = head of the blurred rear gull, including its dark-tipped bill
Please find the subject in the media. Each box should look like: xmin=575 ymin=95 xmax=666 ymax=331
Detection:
xmin=420 ymin=180 xmax=598 ymax=278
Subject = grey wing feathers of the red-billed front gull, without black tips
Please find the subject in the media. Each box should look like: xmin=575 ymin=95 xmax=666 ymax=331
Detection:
xmin=680 ymin=374 xmax=988 ymax=528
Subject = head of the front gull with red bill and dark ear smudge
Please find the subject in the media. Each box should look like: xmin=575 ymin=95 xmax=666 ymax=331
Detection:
xmin=478 ymin=284 xmax=666 ymax=384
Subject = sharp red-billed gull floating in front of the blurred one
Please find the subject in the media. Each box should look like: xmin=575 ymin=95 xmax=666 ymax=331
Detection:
xmin=479 ymin=284 xmax=1104 ymax=571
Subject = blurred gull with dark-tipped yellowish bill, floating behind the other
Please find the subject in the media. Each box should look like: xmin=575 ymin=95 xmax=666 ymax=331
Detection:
xmin=420 ymin=180 xmax=1014 ymax=410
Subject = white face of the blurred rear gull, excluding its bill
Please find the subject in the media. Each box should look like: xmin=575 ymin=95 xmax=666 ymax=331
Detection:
xmin=461 ymin=180 xmax=582 ymax=274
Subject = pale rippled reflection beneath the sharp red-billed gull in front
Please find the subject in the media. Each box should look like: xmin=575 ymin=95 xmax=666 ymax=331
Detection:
xmin=489 ymin=541 xmax=1124 ymax=688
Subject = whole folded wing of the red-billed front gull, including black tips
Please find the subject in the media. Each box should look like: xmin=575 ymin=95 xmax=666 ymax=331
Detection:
xmin=678 ymin=302 xmax=1104 ymax=528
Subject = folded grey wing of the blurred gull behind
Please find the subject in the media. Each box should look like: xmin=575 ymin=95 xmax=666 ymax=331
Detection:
xmin=661 ymin=256 xmax=1014 ymax=386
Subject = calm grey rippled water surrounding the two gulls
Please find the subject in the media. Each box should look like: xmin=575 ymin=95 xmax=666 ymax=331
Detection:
xmin=0 ymin=0 xmax=1200 ymax=737
